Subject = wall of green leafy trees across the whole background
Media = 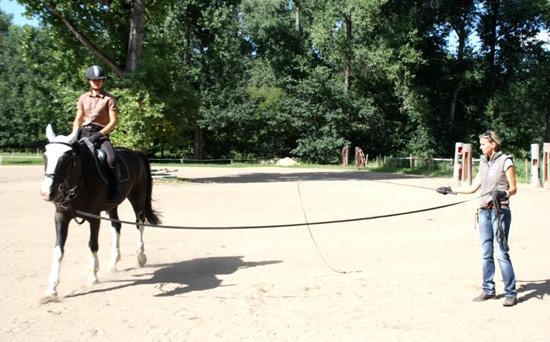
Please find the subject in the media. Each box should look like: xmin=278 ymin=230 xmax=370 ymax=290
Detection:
xmin=0 ymin=0 xmax=550 ymax=163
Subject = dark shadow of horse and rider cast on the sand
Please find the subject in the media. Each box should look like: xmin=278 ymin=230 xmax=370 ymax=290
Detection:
xmin=65 ymin=256 xmax=282 ymax=298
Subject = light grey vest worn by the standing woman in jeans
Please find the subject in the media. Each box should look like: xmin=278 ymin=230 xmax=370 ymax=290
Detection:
xmin=479 ymin=152 xmax=512 ymax=207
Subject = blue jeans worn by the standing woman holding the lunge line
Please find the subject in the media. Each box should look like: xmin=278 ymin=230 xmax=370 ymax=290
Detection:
xmin=479 ymin=208 xmax=517 ymax=297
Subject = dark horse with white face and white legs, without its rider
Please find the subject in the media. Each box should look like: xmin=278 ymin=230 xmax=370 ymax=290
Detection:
xmin=40 ymin=125 xmax=160 ymax=303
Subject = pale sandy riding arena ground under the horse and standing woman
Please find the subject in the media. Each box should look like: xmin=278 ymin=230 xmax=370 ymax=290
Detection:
xmin=0 ymin=166 xmax=550 ymax=342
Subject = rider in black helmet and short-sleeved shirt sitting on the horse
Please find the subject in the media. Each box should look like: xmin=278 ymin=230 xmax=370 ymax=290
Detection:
xmin=73 ymin=65 xmax=120 ymax=203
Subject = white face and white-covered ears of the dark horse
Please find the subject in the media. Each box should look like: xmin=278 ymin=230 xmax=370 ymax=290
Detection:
xmin=40 ymin=125 xmax=78 ymax=201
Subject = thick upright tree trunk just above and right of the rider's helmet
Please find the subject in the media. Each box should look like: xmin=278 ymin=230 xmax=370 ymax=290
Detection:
xmin=125 ymin=0 xmax=145 ymax=71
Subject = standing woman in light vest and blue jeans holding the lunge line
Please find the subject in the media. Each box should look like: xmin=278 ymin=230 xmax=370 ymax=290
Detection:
xmin=437 ymin=131 xmax=517 ymax=306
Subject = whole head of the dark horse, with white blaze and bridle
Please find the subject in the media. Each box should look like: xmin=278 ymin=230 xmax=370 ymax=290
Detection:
xmin=40 ymin=125 xmax=82 ymax=202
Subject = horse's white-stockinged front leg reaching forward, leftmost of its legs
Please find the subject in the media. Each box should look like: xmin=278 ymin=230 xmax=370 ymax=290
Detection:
xmin=42 ymin=210 xmax=71 ymax=303
